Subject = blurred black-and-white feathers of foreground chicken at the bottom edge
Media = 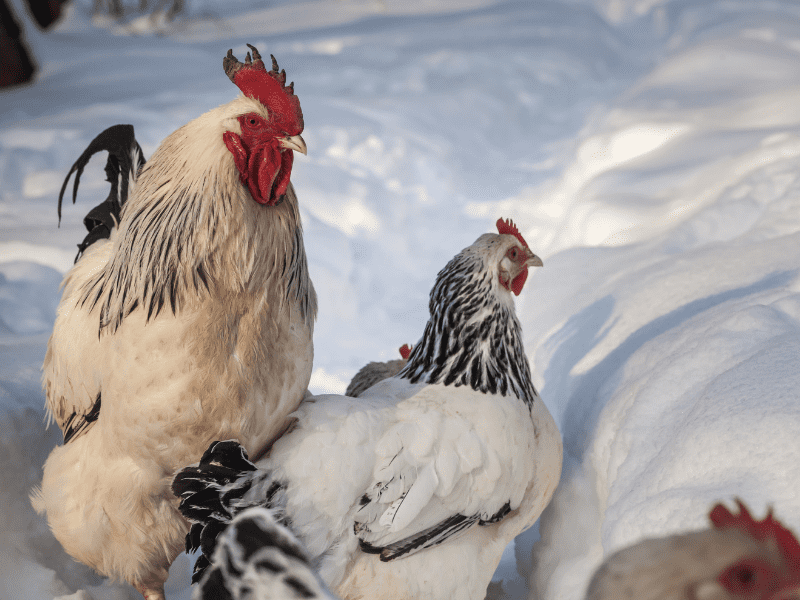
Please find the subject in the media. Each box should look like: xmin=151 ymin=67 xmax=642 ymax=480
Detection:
xmin=198 ymin=508 xmax=336 ymax=600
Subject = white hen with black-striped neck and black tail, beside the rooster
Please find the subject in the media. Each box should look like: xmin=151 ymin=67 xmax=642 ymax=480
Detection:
xmin=173 ymin=220 xmax=562 ymax=600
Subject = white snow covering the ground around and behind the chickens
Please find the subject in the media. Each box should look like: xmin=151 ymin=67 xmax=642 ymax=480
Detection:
xmin=0 ymin=0 xmax=800 ymax=600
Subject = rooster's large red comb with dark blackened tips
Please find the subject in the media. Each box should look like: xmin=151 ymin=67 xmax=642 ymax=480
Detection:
xmin=222 ymin=44 xmax=303 ymax=135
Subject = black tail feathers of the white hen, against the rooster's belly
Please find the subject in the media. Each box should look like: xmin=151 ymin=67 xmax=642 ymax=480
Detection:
xmin=172 ymin=440 xmax=284 ymax=583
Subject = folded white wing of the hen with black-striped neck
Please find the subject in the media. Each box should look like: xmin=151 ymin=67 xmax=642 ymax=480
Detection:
xmin=354 ymin=386 xmax=533 ymax=561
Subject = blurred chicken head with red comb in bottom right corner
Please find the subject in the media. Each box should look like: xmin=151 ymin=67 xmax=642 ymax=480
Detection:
xmin=586 ymin=500 xmax=800 ymax=600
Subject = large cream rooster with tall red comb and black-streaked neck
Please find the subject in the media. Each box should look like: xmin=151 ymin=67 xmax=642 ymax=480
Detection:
xmin=32 ymin=46 xmax=317 ymax=600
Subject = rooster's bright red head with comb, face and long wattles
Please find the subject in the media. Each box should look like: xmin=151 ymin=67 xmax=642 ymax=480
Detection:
xmin=222 ymin=44 xmax=306 ymax=206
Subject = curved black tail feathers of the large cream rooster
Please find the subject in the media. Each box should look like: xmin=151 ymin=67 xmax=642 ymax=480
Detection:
xmin=58 ymin=125 xmax=145 ymax=262
